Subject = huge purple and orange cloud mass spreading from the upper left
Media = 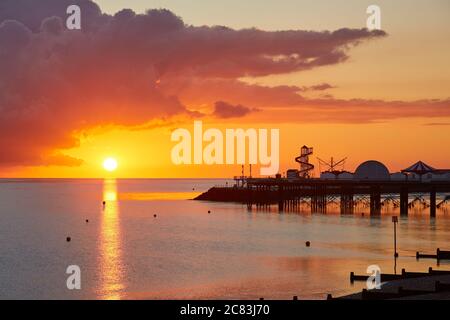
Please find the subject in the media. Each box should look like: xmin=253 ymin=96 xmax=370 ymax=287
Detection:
xmin=0 ymin=0 xmax=442 ymax=165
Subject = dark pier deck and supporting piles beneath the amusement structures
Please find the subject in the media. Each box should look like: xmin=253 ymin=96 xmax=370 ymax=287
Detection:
xmin=195 ymin=178 xmax=450 ymax=217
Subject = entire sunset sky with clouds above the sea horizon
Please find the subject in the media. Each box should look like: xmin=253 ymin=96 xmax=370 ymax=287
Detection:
xmin=0 ymin=0 xmax=450 ymax=178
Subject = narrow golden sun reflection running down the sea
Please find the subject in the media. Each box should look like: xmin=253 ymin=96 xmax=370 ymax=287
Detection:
xmin=99 ymin=179 xmax=124 ymax=300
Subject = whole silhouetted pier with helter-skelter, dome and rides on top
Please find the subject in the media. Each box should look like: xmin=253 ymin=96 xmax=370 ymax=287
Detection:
xmin=195 ymin=149 xmax=450 ymax=217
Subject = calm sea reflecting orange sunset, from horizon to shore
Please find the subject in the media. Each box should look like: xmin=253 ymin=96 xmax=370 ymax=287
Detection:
xmin=0 ymin=179 xmax=450 ymax=299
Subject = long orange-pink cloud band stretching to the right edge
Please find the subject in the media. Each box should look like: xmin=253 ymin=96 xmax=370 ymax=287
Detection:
xmin=164 ymin=78 xmax=450 ymax=123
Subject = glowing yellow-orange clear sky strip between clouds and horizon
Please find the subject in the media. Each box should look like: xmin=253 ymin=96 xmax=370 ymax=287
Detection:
xmin=5 ymin=118 xmax=450 ymax=178
